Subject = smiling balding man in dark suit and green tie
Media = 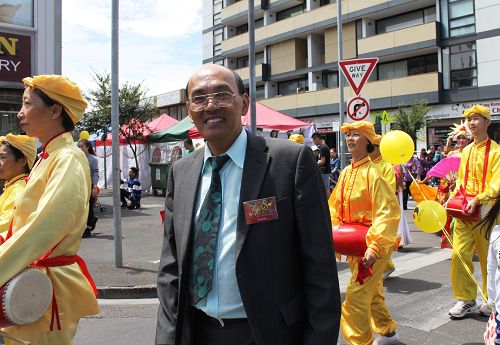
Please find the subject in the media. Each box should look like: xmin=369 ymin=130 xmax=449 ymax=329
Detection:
xmin=156 ymin=65 xmax=340 ymax=345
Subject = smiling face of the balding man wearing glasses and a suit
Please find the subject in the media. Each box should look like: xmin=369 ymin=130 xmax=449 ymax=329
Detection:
xmin=187 ymin=65 xmax=249 ymax=143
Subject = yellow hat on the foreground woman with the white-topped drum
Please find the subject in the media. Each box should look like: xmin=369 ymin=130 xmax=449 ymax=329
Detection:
xmin=23 ymin=75 xmax=87 ymax=123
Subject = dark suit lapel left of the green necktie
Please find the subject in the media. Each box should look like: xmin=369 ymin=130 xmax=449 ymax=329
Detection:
xmin=179 ymin=150 xmax=204 ymax=263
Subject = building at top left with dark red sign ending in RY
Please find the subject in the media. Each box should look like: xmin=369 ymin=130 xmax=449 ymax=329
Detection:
xmin=0 ymin=0 xmax=62 ymax=135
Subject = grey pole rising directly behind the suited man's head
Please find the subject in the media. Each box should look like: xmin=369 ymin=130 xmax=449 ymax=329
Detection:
xmin=248 ymin=0 xmax=257 ymax=135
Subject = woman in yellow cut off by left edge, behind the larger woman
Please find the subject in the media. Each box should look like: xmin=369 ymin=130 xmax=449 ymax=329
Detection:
xmin=0 ymin=133 xmax=36 ymax=244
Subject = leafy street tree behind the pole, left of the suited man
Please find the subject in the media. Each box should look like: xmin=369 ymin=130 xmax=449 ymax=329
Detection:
xmin=77 ymin=73 xmax=157 ymax=167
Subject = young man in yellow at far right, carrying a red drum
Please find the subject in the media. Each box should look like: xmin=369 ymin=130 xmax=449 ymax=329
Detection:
xmin=449 ymin=105 xmax=500 ymax=318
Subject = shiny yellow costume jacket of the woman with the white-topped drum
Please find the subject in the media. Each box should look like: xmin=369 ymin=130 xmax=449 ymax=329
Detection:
xmin=0 ymin=133 xmax=99 ymax=332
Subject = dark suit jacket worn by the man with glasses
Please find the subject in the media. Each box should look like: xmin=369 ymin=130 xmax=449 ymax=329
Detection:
xmin=156 ymin=134 xmax=340 ymax=345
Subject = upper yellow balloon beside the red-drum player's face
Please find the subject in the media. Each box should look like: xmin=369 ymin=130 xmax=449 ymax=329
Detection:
xmin=380 ymin=131 xmax=414 ymax=164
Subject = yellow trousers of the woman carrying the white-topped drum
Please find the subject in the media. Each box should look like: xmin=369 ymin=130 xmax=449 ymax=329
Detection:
xmin=4 ymin=321 xmax=79 ymax=345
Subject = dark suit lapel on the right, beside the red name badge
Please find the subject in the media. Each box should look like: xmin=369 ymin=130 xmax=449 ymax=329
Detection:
xmin=236 ymin=134 xmax=270 ymax=260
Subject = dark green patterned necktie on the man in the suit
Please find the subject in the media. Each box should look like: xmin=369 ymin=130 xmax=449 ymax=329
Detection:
xmin=189 ymin=154 xmax=229 ymax=304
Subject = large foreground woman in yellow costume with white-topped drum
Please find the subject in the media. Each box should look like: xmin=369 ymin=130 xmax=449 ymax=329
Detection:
xmin=0 ymin=75 xmax=99 ymax=345
